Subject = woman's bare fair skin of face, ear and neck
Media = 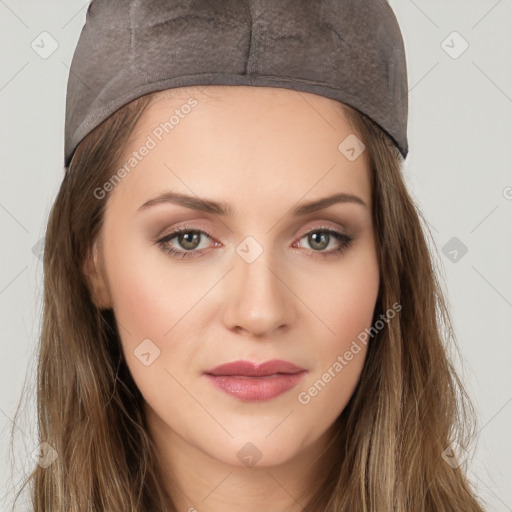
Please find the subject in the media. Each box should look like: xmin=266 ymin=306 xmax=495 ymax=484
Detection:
xmin=85 ymin=86 xmax=379 ymax=512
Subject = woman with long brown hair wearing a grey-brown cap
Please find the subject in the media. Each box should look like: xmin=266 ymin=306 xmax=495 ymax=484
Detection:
xmin=11 ymin=0 xmax=483 ymax=512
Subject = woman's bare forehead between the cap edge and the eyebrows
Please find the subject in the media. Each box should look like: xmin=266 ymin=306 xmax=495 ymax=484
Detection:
xmin=112 ymin=86 xmax=371 ymax=214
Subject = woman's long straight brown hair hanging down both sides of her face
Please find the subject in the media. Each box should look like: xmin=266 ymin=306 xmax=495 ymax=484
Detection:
xmin=10 ymin=86 xmax=483 ymax=512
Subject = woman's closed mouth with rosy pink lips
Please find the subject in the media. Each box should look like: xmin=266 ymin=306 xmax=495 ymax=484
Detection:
xmin=204 ymin=359 xmax=307 ymax=402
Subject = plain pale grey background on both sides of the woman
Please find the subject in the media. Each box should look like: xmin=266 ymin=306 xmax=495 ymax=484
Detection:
xmin=0 ymin=0 xmax=512 ymax=512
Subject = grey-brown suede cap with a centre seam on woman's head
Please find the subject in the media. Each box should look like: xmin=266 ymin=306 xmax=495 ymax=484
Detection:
xmin=64 ymin=0 xmax=408 ymax=167
